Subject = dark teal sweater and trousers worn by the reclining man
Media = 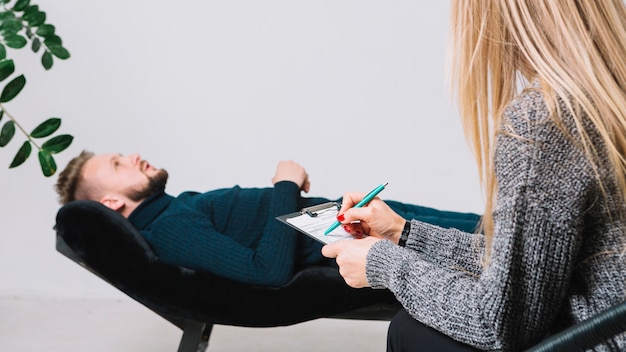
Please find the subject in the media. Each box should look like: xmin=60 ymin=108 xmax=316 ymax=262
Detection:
xmin=129 ymin=181 xmax=478 ymax=286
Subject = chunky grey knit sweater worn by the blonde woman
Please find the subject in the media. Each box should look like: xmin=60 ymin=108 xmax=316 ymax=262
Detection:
xmin=366 ymin=90 xmax=626 ymax=351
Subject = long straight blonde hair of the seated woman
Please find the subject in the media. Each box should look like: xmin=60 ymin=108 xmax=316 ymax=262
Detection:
xmin=449 ymin=0 xmax=626 ymax=257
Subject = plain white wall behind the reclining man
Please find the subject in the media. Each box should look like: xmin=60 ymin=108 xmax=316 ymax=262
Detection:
xmin=0 ymin=0 xmax=483 ymax=297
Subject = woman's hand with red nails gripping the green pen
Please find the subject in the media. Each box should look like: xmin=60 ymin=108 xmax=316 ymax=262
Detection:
xmin=337 ymin=193 xmax=406 ymax=243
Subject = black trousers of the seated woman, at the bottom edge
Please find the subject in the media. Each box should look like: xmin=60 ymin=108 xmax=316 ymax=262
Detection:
xmin=387 ymin=309 xmax=479 ymax=352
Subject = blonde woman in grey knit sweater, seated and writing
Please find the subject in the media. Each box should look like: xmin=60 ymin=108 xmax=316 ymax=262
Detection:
xmin=323 ymin=0 xmax=626 ymax=351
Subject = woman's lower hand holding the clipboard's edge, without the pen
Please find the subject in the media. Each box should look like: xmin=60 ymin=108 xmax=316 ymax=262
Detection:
xmin=322 ymin=237 xmax=380 ymax=288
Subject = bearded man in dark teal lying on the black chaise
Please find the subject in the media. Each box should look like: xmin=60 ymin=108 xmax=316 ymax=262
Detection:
xmin=55 ymin=151 xmax=479 ymax=286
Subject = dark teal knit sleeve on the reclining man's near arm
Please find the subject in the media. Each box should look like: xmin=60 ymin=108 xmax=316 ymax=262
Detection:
xmin=153 ymin=181 xmax=300 ymax=286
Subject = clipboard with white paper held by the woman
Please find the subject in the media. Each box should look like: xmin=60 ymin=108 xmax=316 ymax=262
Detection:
xmin=276 ymin=202 xmax=354 ymax=244
